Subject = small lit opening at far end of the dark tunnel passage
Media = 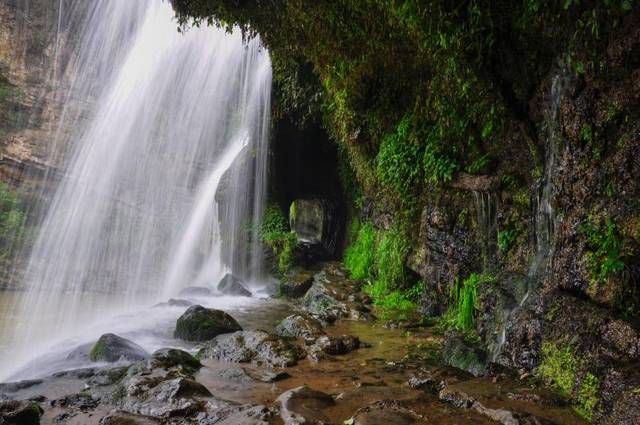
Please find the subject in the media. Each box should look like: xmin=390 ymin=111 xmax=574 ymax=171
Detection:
xmin=289 ymin=199 xmax=325 ymax=244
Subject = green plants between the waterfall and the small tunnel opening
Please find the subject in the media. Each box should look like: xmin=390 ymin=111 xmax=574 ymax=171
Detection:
xmin=260 ymin=204 xmax=298 ymax=274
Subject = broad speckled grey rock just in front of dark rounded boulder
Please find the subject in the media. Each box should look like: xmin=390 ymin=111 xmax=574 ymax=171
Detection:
xmin=199 ymin=331 xmax=301 ymax=367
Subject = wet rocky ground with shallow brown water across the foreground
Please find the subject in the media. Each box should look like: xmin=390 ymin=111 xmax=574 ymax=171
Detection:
xmin=0 ymin=263 xmax=582 ymax=425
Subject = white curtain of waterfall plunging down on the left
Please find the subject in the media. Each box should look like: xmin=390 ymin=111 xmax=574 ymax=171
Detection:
xmin=0 ymin=0 xmax=271 ymax=380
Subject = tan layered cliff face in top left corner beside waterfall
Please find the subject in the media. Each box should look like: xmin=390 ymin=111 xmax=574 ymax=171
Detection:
xmin=0 ymin=0 xmax=80 ymax=190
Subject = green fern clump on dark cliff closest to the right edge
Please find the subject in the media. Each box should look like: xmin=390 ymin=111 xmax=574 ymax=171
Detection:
xmin=581 ymin=217 xmax=625 ymax=283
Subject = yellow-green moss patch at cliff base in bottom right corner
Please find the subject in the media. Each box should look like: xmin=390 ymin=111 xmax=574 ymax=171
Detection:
xmin=538 ymin=342 xmax=600 ymax=421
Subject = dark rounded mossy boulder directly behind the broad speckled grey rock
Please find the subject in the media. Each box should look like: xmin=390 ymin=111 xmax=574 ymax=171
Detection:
xmin=174 ymin=305 xmax=242 ymax=341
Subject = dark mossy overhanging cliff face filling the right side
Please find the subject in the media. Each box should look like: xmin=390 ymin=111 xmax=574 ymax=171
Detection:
xmin=173 ymin=0 xmax=640 ymax=423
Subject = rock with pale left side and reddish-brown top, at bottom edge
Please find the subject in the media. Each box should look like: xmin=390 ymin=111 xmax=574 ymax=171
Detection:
xmin=276 ymin=386 xmax=335 ymax=425
